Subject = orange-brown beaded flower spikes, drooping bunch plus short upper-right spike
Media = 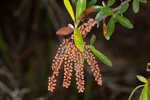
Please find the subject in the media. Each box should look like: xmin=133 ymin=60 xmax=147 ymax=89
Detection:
xmin=48 ymin=20 xmax=102 ymax=93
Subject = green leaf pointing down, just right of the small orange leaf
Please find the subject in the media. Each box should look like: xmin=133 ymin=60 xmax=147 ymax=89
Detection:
xmin=105 ymin=16 xmax=116 ymax=40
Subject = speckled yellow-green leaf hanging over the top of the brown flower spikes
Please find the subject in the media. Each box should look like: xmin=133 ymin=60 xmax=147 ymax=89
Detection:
xmin=73 ymin=28 xmax=84 ymax=52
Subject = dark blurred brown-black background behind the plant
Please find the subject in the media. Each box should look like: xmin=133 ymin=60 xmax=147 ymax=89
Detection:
xmin=0 ymin=0 xmax=150 ymax=100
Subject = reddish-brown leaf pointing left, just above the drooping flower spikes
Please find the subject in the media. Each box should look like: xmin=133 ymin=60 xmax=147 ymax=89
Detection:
xmin=56 ymin=27 xmax=73 ymax=35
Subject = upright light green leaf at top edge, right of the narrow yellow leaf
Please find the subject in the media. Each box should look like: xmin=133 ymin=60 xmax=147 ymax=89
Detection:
xmin=76 ymin=0 xmax=86 ymax=19
